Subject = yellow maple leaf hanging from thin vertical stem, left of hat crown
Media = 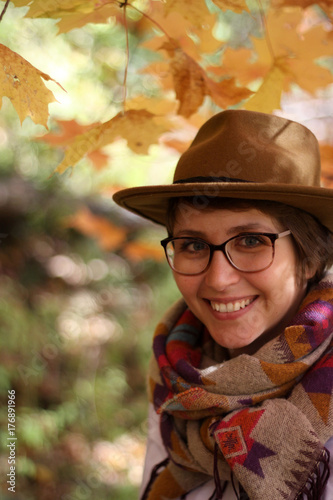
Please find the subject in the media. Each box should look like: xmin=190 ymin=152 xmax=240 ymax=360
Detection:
xmin=56 ymin=109 xmax=169 ymax=173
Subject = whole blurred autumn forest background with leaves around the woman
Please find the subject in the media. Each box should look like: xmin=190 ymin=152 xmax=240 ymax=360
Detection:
xmin=0 ymin=0 xmax=333 ymax=500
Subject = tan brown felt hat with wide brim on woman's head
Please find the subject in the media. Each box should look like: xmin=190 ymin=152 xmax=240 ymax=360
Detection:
xmin=113 ymin=110 xmax=333 ymax=231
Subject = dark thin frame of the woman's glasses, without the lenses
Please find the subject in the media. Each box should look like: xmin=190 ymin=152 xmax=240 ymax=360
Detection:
xmin=161 ymin=229 xmax=292 ymax=276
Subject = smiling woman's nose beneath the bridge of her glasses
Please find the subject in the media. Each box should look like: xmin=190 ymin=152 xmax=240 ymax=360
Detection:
xmin=205 ymin=250 xmax=241 ymax=290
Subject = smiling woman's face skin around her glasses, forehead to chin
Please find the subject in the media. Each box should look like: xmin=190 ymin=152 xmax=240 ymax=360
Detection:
xmin=173 ymin=208 xmax=309 ymax=355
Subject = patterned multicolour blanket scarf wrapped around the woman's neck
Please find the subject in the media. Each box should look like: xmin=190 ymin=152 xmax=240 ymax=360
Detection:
xmin=146 ymin=275 xmax=333 ymax=500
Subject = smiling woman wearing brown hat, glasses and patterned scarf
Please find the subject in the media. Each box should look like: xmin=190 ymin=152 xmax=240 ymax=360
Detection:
xmin=115 ymin=110 xmax=333 ymax=500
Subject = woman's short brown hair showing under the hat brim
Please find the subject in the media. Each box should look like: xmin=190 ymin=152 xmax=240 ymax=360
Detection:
xmin=167 ymin=196 xmax=333 ymax=283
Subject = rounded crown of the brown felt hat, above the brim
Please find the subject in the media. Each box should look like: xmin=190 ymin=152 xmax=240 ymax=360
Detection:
xmin=174 ymin=110 xmax=320 ymax=187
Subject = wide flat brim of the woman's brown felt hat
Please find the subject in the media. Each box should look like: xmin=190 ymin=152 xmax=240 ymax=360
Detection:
xmin=113 ymin=182 xmax=333 ymax=231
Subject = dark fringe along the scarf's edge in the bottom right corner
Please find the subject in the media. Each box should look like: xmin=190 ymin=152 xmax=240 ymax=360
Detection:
xmin=296 ymin=448 xmax=330 ymax=500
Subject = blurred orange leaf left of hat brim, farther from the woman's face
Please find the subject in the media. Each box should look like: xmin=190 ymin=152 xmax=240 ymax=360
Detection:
xmin=65 ymin=208 xmax=127 ymax=251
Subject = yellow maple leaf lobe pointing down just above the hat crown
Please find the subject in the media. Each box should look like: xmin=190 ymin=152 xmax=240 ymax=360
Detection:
xmin=244 ymin=60 xmax=286 ymax=113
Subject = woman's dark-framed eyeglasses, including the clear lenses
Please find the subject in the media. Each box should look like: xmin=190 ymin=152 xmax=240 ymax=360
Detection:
xmin=161 ymin=229 xmax=291 ymax=276
